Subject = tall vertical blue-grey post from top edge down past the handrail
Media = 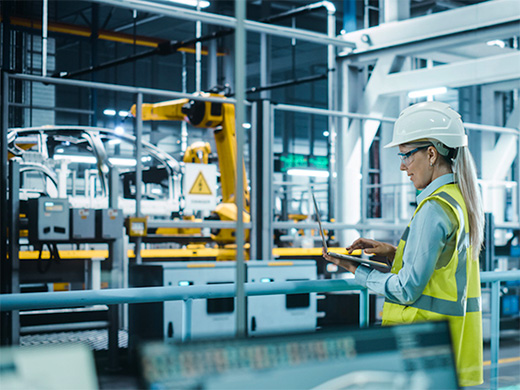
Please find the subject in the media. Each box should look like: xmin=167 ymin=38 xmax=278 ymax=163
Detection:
xmin=235 ymin=0 xmax=247 ymax=337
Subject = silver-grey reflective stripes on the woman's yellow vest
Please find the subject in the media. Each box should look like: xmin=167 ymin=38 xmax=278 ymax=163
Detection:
xmin=388 ymin=192 xmax=481 ymax=316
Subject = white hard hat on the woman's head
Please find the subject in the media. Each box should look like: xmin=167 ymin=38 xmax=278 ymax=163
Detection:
xmin=385 ymin=102 xmax=468 ymax=148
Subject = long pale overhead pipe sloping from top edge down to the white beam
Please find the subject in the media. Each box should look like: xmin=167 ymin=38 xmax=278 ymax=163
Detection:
xmin=93 ymin=0 xmax=355 ymax=48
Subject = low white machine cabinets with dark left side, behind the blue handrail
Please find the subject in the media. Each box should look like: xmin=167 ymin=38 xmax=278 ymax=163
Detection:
xmin=129 ymin=260 xmax=317 ymax=344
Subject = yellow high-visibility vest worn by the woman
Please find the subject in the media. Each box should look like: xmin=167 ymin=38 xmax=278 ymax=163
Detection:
xmin=383 ymin=184 xmax=484 ymax=386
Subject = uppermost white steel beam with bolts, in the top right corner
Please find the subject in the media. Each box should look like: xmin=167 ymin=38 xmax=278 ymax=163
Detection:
xmin=340 ymin=0 xmax=520 ymax=62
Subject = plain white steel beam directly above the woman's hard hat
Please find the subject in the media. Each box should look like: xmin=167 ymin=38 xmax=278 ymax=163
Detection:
xmin=379 ymin=52 xmax=520 ymax=95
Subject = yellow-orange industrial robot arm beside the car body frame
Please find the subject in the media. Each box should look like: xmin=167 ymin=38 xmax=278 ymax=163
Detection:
xmin=130 ymin=93 xmax=250 ymax=244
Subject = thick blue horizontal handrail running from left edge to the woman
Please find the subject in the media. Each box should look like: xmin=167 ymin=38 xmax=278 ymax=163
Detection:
xmin=0 ymin=279 xmax=363 ymax=311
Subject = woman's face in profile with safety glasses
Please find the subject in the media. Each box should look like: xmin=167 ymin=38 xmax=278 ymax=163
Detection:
xmin=399 ymin=144 xmax=433 ymax=190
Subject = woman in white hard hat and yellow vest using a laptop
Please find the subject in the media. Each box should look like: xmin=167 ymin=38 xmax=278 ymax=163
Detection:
xmin=324 ymin=102 xmax=484 ymax=386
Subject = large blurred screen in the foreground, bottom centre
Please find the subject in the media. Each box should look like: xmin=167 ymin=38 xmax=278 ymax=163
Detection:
xmin=141 ymin=322 xmax=458 ymax=389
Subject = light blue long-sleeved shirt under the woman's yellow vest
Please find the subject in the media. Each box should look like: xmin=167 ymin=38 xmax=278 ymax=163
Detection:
xmin=355 ymin=173 xmax=458 ymax=305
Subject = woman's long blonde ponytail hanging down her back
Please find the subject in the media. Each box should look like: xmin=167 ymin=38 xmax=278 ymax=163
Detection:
xmin=452 ymin=146 xmax=484 ymax=260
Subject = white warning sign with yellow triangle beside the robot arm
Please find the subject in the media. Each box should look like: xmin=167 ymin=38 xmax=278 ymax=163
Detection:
xmin=182 ymin=164 xmax=217 ymax=211
